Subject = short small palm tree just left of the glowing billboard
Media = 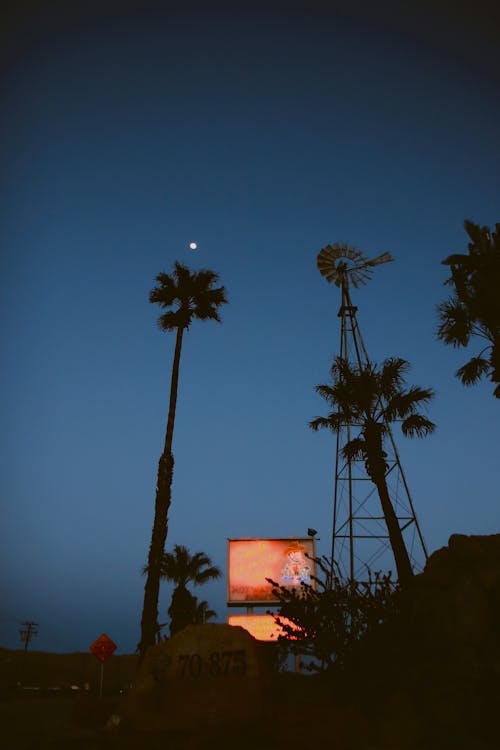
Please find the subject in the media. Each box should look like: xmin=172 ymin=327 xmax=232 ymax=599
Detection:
xmin=160 ymin=544 xmax=222 ymax=635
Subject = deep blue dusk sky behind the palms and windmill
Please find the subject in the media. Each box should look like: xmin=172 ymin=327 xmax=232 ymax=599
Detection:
xmin=0 ymin=2 xmax=500 ymax=652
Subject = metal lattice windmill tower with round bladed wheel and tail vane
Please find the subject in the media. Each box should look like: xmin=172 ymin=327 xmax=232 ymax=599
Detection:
xmin=317 ymin=244 xmax=427 ymax=580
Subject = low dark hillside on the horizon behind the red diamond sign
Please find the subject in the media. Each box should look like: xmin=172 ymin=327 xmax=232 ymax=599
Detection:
xmin=0 ymin=648 xmax=138 ymax=693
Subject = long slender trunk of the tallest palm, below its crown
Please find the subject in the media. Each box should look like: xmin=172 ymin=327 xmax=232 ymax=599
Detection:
xmin=138 ymin=328 xmax=184 ymax=662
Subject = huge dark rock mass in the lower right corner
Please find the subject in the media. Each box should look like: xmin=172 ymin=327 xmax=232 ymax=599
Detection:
xmin=364 ymin=534 xmax=500 ymax=750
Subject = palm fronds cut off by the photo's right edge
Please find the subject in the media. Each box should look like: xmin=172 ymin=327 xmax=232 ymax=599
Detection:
xmin=437 ymin=221 xmax=500 ymax=398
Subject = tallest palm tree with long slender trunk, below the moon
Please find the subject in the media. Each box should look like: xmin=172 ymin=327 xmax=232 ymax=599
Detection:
xmin=138 ymin=261 xmax=227 ymax=660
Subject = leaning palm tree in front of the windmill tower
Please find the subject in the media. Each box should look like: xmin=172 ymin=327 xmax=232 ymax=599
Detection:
xmin=310 ymin=357 xmax=435 ymax=584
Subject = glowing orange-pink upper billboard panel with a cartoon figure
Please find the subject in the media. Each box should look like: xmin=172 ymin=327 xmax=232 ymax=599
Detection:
xmin=227 ymin=537 xmax=315 ymax=606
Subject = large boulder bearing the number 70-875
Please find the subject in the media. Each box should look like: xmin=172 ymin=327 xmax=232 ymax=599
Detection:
xmin=120 ymin=624 xmax=268 ymax=730
